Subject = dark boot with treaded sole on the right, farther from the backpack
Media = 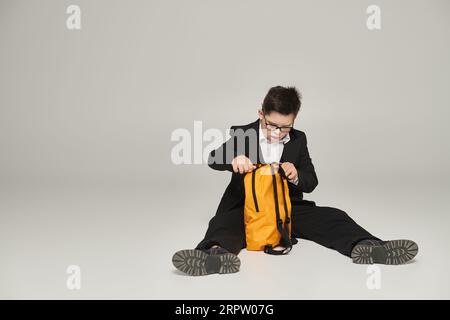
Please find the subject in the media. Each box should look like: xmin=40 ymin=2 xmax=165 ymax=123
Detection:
xmin=351 ymin=239 xmax=419 ymax=265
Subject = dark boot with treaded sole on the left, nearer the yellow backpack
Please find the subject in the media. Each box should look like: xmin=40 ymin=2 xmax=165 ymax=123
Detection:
xmin=172 ymin=249 xmax=241 ymax=276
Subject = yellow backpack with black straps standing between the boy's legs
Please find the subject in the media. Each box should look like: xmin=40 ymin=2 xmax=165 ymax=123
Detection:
xmin=244 ymin=163 xmax=297 ymax=255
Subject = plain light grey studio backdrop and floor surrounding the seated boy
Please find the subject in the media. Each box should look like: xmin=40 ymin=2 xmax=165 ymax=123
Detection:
xmin=0 ymin=0 xmax=450 ymax=299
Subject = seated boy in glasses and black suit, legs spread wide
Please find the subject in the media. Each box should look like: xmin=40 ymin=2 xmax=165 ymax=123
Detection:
xmin=172 ymin=86 xmax=418 ymax=276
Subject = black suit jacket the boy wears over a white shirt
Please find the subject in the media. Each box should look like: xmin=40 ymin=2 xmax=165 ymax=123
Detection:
xmin=208 ymin=119 xmax=318 ymax=214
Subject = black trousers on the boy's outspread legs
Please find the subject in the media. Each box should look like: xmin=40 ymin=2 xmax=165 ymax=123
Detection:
xmin=196 ymin=201 xmax=381 ymax=257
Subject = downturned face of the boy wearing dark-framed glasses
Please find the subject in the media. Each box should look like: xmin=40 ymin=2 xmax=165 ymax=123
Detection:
xmin=258 ymin=109 xmax=295 ymax=142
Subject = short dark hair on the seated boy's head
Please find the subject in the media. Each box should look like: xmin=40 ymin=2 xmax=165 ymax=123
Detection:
xmin=262 ymin=86 xmax=302 ymax=115
